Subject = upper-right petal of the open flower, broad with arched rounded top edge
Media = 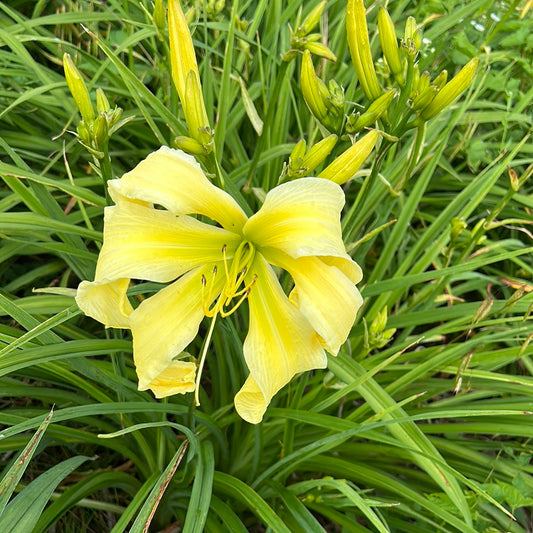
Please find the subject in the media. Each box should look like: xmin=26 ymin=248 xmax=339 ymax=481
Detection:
xmin=243 ymin=178 xmax=346 ymax=258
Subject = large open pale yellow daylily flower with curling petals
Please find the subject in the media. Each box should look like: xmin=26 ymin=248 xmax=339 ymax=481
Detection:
xmin=76 ymin=147 xmax=362 ymax=423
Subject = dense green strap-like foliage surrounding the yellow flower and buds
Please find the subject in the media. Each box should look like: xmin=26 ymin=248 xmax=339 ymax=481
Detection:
xmin=0 ymin=0 xmax=533 ymax=533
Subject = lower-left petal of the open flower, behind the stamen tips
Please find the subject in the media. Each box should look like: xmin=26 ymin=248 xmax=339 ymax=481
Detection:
xmin=130 ymin=264 xmax=225 ymax=390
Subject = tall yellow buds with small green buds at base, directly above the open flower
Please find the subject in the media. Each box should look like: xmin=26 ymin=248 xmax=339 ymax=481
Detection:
xmin=168 ymin=0 xmax=214 ymax=156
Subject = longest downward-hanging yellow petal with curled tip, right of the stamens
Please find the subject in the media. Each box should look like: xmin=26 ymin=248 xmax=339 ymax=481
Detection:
xmin=235 ymin=254 xmax=327 ymax=424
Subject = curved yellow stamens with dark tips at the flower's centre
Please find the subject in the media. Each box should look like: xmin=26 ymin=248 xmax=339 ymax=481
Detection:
xmin=202 ymin=241 xmax=257 ymax=317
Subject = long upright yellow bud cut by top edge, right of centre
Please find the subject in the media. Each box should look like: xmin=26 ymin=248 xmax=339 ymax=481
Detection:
xmin=346 ymin=0 xmax=381 ymax=100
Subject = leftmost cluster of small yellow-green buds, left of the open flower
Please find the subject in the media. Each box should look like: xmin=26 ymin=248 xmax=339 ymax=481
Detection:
xmin=63 ymin=53 xmax=128 ymax=159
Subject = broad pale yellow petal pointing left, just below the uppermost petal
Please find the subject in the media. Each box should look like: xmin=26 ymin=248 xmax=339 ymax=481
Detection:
xmin=96 ymin=201 xmax=242 ymax=282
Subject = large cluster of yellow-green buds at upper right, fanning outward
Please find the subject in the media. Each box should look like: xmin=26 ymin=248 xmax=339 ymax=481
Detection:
xmin=346 ymin=0 xmax=479 ymax=134
